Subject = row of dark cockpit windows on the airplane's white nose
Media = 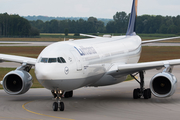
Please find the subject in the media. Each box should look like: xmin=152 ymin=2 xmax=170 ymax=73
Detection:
xmin=41 ymin=57 xmax=66 ymax=63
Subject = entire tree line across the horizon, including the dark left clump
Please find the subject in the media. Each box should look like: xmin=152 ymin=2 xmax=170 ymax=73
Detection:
xmin=0 ymin=12 xmax=180 ymax=37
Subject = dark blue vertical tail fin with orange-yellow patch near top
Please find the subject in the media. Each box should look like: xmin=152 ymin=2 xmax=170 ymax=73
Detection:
xmin=126 ymin=0 xmax=138 ymax=35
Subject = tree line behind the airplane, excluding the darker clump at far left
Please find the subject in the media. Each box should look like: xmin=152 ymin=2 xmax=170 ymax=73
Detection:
xmin=30 ymin=12 xmax=180 ymax=34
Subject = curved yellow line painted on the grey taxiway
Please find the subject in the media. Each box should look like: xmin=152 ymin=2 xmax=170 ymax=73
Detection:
xmin=22 ymin=101 xmax=74 ymax=120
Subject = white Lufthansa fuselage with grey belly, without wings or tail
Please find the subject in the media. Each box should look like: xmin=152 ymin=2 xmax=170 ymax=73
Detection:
xmin=35 ymin=35 xmax=141 ymax=91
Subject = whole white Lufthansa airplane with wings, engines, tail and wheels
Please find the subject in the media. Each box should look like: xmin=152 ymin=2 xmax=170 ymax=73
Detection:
xmin=0 ymin=0 xmax=180 ymax=111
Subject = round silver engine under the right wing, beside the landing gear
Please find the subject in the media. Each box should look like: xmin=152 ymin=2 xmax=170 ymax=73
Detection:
xmin=150 ymin=72 xmax=177 ymax=98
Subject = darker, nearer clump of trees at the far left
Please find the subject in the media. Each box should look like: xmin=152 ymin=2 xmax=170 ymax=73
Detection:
xmin=0 ymin=13 xmax=40 ymax=37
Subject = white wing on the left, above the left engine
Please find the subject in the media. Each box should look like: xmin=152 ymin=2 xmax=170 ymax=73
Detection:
xmin=0 ymin=54 xmax=37 ymax=66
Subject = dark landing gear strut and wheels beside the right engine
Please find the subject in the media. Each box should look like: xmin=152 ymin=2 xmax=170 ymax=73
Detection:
xmin=130 ymin=71 xmax=151 ymax=99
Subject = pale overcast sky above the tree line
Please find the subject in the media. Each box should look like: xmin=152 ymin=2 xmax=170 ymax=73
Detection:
xmin=0 ymin=0 xmax=180 ymax=19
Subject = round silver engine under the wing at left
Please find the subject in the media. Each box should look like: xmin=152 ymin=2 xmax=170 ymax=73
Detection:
xmin=3 ymin=70 xmax=32 ymax=95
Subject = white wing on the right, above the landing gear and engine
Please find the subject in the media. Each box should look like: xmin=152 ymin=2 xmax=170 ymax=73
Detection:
xmin=107 ymin=59 xmax=180 ymax=77
